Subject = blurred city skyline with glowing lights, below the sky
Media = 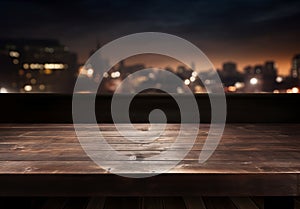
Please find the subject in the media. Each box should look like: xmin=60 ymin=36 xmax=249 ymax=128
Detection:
xmin=0 ymin=39 xmax=300 ymax=94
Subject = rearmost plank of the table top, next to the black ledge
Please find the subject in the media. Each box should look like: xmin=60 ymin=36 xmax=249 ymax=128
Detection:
xmin=0 ymin=123 xmax=300 ymax=137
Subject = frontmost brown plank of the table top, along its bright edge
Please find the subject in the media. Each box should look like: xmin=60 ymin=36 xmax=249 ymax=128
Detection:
xmin=0 ymin=160 xmax=298 ymax=175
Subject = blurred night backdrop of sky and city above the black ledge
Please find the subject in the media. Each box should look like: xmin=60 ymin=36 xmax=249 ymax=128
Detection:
xmin=0 ymin=0 xmax=300 ymax=94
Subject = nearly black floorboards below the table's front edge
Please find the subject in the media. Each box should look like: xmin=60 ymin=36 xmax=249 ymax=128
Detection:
xmin=0 ymin=196 xmax=268 ymax=209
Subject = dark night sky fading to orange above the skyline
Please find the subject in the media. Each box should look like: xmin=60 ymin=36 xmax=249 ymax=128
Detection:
xmin=0 ymin=0 xmax=300 ymax=74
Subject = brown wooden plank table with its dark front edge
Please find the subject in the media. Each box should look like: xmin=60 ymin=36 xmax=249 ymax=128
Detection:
xmin=0 ymin=124 xmax=300 ymax=196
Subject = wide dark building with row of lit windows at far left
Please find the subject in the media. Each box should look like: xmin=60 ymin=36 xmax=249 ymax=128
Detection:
xmin=0 ymin=39 xmax=78 ymax=93
